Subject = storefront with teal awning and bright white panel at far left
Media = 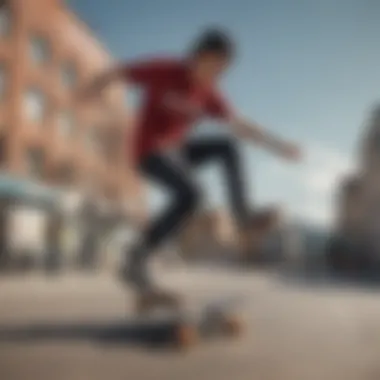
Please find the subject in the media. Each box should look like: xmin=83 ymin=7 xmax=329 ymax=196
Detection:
xmin=0 ymin=174 xmax=60 ymax=269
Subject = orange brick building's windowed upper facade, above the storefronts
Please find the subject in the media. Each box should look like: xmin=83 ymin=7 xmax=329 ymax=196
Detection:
xmin=0 ymin=0 xmax=143 ymax=272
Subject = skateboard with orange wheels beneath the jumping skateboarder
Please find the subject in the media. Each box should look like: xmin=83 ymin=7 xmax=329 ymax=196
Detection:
xmin=132 ymin=297 xmax=244 ymax=350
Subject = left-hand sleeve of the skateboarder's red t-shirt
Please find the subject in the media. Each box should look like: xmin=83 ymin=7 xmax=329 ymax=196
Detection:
xmin=122 ymin=58 xmax=175 ymax=85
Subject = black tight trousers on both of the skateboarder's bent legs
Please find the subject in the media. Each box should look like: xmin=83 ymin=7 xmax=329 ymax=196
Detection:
xmin=135 ymin=138 xmax=249 ymax=260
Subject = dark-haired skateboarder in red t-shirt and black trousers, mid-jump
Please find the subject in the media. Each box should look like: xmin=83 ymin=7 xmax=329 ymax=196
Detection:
xmin=81 ymin=29 xmax=300 ymax=303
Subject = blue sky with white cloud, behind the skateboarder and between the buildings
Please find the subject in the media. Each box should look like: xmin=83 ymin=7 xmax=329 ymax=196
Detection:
xmin=68 ymin=0 xmax=380 ymax=226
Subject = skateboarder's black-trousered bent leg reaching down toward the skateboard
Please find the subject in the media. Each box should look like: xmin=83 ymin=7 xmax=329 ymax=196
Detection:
xmin=123 ymin=155 xmax=198 ymax=292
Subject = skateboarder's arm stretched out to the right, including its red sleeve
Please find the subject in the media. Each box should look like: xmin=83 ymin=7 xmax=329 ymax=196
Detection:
xmin=207 ymin=93 xmax=300 ymax=160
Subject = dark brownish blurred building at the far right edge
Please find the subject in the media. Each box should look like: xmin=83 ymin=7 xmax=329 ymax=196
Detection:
xmin=330 ymin=105 xmax=380 ymax=267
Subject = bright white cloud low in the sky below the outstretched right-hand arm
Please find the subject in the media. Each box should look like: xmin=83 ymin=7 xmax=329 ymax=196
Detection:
xmin=256 ymin=143 xmax=354 ymax=224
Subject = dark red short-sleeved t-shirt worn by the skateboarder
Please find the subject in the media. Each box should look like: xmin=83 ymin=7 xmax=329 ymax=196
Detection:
xmin=123 ymin=59 xmax=231 ymax=161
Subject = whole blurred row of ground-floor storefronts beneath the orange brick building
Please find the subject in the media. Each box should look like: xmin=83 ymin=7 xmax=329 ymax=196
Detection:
xmin=0 ymin=175 xmax=140 ymax=272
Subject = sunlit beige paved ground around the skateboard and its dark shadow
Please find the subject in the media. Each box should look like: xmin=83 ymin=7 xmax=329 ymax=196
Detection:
xmin=0 ymin=269 xmax=380 ymax=380
